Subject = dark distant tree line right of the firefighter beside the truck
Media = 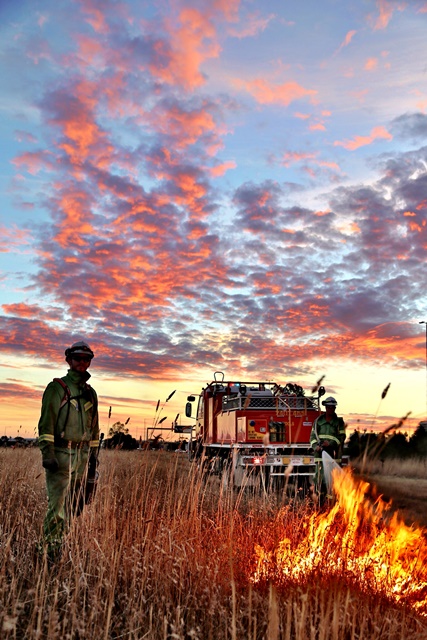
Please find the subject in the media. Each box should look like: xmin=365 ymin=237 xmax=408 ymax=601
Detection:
xmin=344 ymin=423 xmax=427 ymax=460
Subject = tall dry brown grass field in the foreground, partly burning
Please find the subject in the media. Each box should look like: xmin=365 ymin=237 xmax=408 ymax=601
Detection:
xmin=0 ymin=449 xmax=427 ymax=640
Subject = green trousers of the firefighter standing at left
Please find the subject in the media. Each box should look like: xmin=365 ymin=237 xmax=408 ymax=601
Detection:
xmin=43 ymin=449 xmax=88 ymax=551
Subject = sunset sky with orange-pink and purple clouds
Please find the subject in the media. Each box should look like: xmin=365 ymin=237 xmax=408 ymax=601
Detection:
xmin=0 ymin=0 xmax=427 ymax=436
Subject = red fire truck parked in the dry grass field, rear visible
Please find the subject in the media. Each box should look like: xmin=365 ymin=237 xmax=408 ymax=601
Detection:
xmin=185 ymin=371 xmax=325 ymax=487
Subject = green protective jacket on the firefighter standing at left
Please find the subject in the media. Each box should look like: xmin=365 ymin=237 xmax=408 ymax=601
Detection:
xmin=38 ymin=369 xmax=99 ymax=458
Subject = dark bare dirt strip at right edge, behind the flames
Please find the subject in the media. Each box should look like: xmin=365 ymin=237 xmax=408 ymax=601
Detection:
xmin=364 ymin=474 xmax=427 ymax=535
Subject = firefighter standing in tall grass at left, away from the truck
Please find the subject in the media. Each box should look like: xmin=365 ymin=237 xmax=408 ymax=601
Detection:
xmin=38 ymin=341 xmax=99 ymax=559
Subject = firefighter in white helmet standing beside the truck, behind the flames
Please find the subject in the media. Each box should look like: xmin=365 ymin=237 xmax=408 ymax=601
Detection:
xmin=310 ymin=396 xmax=345 ymax=503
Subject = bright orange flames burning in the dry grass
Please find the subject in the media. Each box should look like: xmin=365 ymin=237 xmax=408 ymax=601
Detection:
xmin=251 ymin=469 xmax=427 ymax=616
